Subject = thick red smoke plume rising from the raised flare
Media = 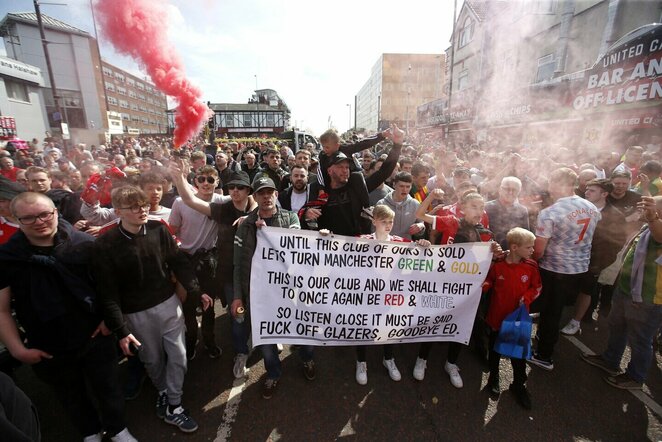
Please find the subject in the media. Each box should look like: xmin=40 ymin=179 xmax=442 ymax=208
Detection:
xmin=94 ymin=0 xmax=212 ymax=147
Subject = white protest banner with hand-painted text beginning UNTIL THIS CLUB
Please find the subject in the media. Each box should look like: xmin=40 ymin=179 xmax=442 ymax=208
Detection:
xmin=250 ymin=227 xmax=492 ymax=345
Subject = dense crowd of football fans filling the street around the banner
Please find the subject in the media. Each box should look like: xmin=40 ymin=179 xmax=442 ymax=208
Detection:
xmin=0 ymin=126 xmax=662 ymax=441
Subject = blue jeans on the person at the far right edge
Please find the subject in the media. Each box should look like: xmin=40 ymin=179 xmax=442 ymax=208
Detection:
xmin=602 ymin=288 xmax=662 ymax=382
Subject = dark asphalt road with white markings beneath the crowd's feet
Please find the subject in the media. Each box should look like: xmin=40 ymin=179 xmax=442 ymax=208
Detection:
xmin=11 ymin=305 xmax=662 ymax=442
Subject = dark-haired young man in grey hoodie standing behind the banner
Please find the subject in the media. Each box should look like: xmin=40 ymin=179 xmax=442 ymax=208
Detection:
xmin=377 ymin=172 xmax=425 ymax=239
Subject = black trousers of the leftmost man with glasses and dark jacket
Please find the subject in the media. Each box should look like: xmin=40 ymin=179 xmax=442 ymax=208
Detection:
xmin=32 ymin=335 xmax=126 ymax=436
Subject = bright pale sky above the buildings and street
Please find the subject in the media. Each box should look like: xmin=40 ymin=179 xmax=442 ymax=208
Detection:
xmin=0 ymin=0 xmax=462 ymax=135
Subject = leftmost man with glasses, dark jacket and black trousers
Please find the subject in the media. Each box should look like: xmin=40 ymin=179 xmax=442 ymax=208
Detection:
xmin=0 ymin=192 xmax=135 ymax=441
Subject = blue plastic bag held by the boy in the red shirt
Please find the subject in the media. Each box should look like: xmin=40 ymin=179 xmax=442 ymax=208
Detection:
xmin=494 ymin=304 xmax=533 ymax=359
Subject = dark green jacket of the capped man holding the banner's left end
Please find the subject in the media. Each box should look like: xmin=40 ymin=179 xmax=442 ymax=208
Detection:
xmin=233 ymin=208 xmax=301 ymax=306
